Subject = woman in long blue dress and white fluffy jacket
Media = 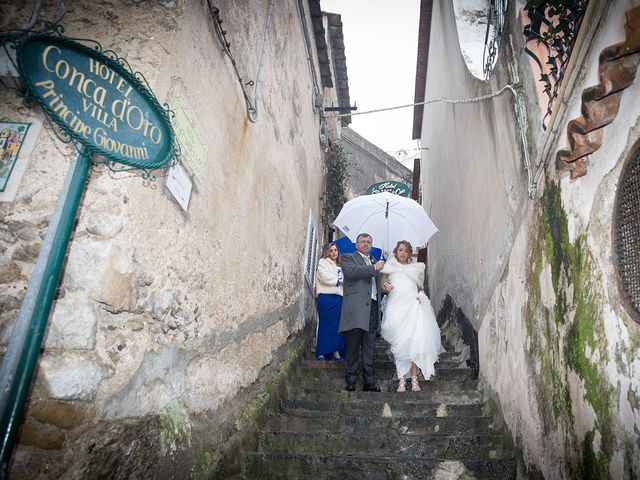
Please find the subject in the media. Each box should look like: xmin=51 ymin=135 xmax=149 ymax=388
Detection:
xmin=316 ymin=243 xmax=347 ymax=361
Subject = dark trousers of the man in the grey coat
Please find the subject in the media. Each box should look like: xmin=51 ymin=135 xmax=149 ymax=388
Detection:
xmin=344 ymin=300 xmax=378 ymax=385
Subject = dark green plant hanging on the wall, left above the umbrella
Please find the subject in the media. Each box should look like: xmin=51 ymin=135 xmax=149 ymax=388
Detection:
xmin=322 ymin=143 xmax=349 ymax=231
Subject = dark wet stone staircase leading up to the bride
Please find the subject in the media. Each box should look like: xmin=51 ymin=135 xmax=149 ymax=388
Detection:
xmin=230 ymin=339 xmax=516 ymax=480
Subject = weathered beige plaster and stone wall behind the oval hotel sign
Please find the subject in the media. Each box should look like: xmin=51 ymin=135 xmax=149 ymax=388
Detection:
xmin=0 ymin=0 xmax=323 ymax=478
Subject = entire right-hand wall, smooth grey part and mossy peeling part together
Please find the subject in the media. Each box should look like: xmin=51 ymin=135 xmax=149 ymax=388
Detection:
xmin=423 ymin=0 xmax=640 ymax=479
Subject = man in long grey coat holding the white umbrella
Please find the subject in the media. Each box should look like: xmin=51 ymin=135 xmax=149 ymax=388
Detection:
xmin=339 ymin=233 xmax=384 ymax=392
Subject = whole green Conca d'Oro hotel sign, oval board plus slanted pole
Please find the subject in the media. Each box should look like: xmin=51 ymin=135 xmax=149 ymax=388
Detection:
xmin=0 ymin=33 xmax=177 ymax=477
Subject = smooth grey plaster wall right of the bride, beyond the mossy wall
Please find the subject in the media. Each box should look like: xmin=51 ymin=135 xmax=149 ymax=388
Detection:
xmin=422 ymin=0 xmax=526 ymax=328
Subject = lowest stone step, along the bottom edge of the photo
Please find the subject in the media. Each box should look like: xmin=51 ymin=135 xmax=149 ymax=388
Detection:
xmin=243 ymin=453 xmax=516 ymax=480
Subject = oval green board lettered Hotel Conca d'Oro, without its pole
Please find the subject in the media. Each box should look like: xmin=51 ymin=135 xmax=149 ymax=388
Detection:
xmin=17 ymin=33 xmax=175 ymax=170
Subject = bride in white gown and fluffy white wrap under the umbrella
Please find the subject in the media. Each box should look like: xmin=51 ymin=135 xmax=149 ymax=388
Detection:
xmin=381 ymin=240 xmax=444 ymax=392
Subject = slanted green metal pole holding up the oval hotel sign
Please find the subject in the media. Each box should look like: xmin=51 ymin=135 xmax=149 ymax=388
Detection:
xmin=0 ymin=147 xmax=91 ymax=478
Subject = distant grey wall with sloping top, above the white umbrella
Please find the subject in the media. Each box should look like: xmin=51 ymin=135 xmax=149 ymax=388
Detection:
xmin=341 ymin=128 xmax=413 ymax=199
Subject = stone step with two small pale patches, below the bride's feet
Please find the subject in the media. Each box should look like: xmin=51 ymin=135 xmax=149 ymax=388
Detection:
xmin=280 ymin=393 xmax=482 ymax=418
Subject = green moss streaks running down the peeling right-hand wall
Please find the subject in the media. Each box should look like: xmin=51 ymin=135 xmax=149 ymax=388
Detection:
xmin=525 ymin=182 xmax=616 ymax=479
